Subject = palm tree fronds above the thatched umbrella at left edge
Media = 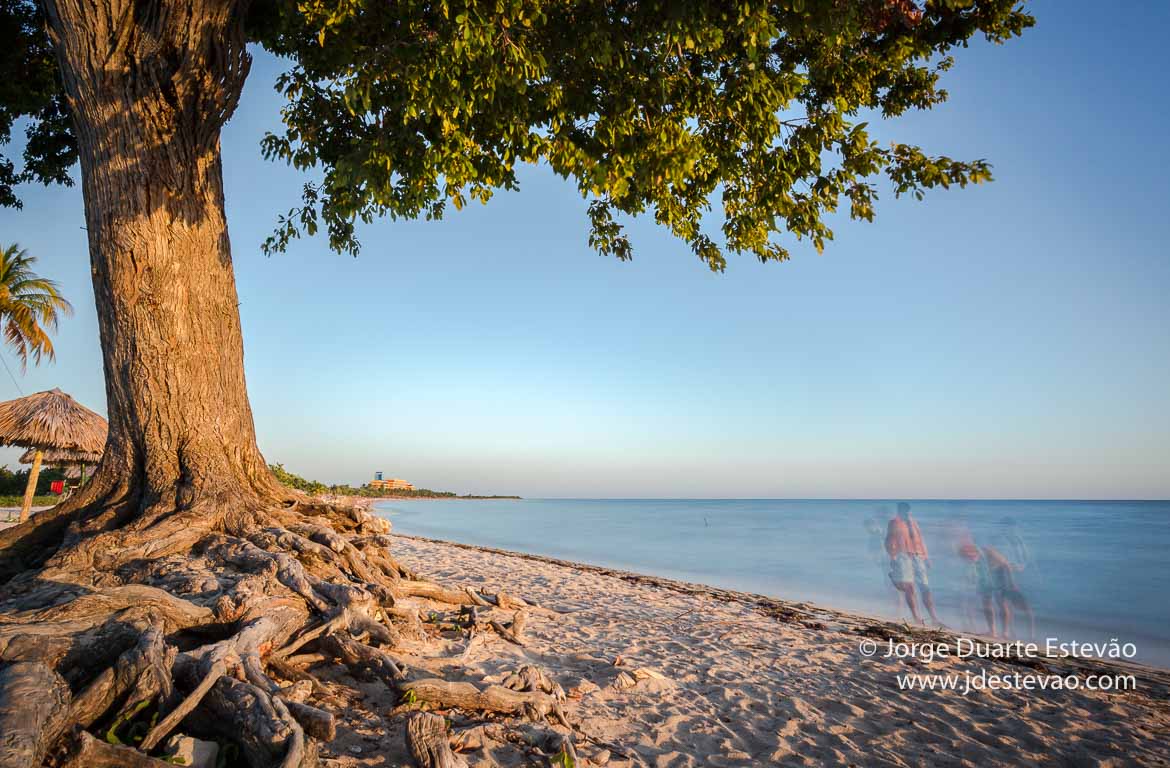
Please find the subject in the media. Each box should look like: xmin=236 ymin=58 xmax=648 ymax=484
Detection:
xmin=0 ymin=245 xmax=73 ymax=370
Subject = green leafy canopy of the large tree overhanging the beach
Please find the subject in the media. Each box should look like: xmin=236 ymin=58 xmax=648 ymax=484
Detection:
xmin=0 ymin=0 xmax=1033 ymax=269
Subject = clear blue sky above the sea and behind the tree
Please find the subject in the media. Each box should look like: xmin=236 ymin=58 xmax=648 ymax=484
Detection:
xmin=0 ymin=0 xmax=1170 ymax=499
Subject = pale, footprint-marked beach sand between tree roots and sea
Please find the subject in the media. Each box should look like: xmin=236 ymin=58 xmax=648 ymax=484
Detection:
xmin=294 ymin=536 xmax=1170 ymax=768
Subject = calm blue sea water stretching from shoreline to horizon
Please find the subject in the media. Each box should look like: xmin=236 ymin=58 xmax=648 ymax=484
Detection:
xmin=378 ymin=499 xmax=1170 ymax=666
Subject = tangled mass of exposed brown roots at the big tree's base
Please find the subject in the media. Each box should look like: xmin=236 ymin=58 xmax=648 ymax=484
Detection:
xmin=0 ymin=488 xmax=594 ymax=768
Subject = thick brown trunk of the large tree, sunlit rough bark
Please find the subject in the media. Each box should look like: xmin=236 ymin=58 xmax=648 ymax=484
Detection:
xmin=46 ymin=0 xmax=275 ymax=526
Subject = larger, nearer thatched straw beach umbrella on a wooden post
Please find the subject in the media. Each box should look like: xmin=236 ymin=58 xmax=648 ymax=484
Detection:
xmin=0 ymin=389 xmax=110 ymax=522
